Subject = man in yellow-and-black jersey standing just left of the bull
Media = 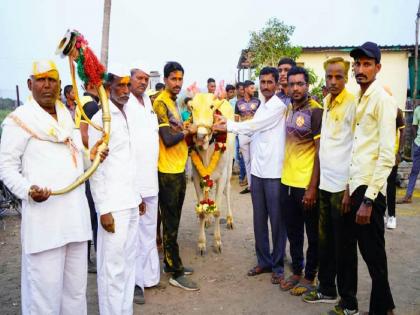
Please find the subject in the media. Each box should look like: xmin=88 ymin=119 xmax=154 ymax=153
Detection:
xmin=153 ymin=61 xmax=199 ymax=291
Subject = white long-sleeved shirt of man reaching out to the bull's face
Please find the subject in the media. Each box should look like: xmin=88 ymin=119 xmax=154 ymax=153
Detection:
xmin=227 ymin=95 xmax=287 ymax=178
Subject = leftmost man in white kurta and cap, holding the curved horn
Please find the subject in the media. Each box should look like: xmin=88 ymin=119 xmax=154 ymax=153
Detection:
xmin=0 ymin=61 xmax=91 ymax=315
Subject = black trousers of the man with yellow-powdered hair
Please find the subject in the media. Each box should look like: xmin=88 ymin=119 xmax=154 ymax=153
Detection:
xmin=318 ymin=190 xmax=358 ymax=309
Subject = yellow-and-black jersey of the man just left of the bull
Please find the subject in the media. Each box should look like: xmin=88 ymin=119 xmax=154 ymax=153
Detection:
xmin=153 ymin=90 xmax=188 ymax=174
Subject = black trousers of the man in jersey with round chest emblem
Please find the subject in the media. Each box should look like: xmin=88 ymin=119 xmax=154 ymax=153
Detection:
xmin=280 ymin=184 xmax=319 ymax=281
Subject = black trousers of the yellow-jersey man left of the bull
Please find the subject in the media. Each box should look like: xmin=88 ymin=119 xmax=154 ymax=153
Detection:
xmin=158 ymin=172 xmax=187 ymax=278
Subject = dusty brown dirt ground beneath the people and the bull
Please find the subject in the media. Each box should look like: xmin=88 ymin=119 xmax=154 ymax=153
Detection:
xmin=0 ymin=180 xmax=420 ymax=315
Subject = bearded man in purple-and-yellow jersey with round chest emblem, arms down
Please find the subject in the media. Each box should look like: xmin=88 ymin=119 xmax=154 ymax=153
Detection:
xmin=280 ymin=67 xmax=322 ymax=295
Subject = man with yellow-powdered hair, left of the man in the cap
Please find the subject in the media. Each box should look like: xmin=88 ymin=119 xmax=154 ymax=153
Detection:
xmin=303 ymin=57 xmax=358 ymax=315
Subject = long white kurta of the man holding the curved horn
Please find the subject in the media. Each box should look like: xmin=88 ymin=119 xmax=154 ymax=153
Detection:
xmin=0 ymin=104 xmax=92 ymax=254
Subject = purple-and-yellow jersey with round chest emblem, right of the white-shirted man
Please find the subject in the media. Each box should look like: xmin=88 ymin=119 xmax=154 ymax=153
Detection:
xmin=281 ymin=99 xmax=322 ymax=189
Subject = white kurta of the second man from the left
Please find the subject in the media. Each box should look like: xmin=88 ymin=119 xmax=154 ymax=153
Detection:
xmin=88 ymin=100 xmax=142 ymax=215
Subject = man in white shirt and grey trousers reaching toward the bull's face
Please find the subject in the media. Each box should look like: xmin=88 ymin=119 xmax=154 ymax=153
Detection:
xmin=213 ymin=67 xmax=287 ymax=284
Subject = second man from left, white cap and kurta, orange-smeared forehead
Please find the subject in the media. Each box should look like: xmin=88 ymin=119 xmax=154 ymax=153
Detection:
xmin=89 ymin=66 xmax=141 ymax=315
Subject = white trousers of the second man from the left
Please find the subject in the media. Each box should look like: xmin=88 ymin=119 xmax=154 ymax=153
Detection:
xmin=97 ymin=207 xmax=139 ymax=315
